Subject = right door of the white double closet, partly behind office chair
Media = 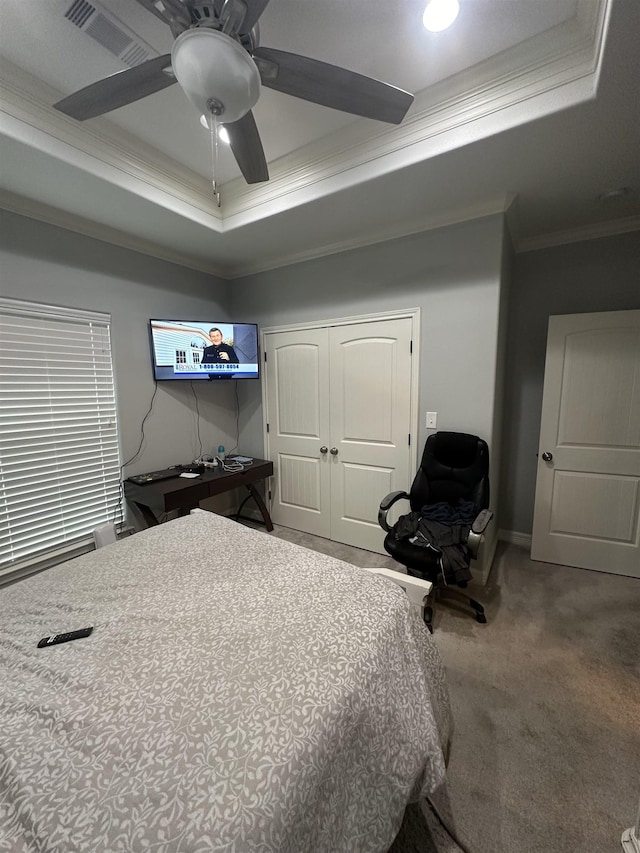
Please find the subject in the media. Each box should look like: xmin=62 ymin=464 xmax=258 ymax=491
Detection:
xmin=329 ymin=318 xmax=415 ymax=553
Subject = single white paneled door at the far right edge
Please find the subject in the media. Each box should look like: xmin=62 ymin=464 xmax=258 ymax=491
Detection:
xmin=531 ymin=310 xmax=640 ymax=577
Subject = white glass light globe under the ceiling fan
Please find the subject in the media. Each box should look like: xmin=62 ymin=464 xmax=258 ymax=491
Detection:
xmin=171 ymin=29 xmax=260 ymax=124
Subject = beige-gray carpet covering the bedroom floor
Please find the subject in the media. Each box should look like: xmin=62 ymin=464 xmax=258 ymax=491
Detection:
xmin=258 ymin=528 xmax=640 ymax=853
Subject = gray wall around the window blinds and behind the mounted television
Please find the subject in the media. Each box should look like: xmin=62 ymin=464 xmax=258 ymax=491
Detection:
xmin=0 ymin=212 xmax=236 ymax=476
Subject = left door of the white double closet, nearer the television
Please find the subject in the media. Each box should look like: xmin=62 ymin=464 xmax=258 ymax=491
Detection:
xmin=266 ymin=329 xmax=331 ymax=538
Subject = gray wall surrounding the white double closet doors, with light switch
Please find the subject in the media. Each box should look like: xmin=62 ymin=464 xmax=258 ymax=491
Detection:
xmin=231 ymin=216 xmax=504 ymax=466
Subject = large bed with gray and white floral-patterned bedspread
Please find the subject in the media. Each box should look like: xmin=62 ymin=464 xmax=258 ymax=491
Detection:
xmin=0 ymin=510 xmax=450 ymax=853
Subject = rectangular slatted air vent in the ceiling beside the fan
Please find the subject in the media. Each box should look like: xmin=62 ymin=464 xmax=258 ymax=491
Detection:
xmin=65 ymin=0 xmax=159 ymax=68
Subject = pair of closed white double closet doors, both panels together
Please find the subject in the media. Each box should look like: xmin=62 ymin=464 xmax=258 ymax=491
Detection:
xmin=265 ymin=317 xmax=415 ymax=553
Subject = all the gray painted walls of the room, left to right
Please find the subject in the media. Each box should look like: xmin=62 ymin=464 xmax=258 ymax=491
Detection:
xmin=0 ymin=206 xmax=640 ymax=533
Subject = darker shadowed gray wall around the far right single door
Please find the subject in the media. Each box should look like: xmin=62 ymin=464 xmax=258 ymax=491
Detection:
xmin=500 ymin=226 xmax=640 ymax=534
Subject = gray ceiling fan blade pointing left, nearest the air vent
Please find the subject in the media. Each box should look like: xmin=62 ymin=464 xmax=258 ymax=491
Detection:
xmin=53 ymin=53 xmax=176 ymax=121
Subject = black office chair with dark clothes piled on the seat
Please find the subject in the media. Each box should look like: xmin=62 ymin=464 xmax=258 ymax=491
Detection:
xmin=378 ymin=432 xmax=493 ymax=631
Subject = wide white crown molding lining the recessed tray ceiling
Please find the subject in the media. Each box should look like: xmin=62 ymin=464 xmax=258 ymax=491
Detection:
xmin=2 ymin=0 xmax=611 ymax=233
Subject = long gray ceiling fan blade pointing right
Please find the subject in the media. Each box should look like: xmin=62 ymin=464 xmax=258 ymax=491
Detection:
xmin=253 ymin=47 xmax=413 ymax=124
